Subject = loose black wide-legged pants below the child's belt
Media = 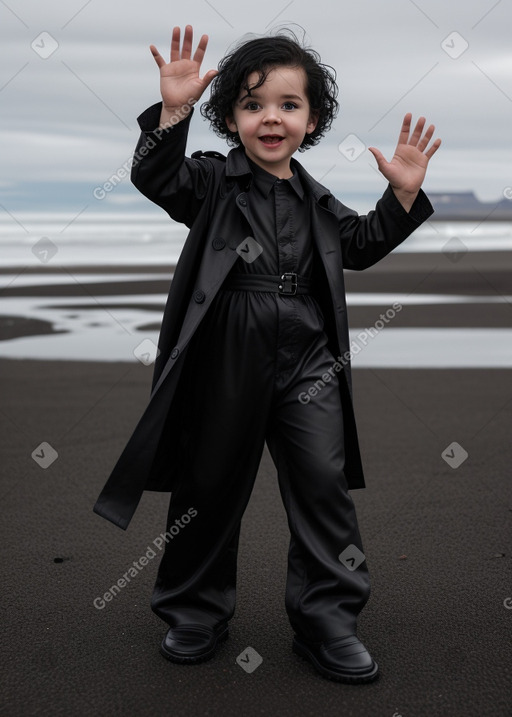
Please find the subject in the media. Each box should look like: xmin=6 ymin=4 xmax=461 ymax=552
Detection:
xmin=151 ymin=290 xmax=370 ymax=640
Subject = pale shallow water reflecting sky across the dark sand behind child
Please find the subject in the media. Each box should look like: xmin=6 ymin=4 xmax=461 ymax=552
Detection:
xmin=0 ymin=286 xmax=512 ymax=368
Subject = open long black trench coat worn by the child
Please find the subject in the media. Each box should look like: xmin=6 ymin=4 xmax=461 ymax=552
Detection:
xmin=94 ymin=103 xmax=434 ymax=529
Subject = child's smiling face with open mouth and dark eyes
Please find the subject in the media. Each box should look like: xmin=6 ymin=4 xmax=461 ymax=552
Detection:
xmin=226 ymin=67 xmax=317 ymax=179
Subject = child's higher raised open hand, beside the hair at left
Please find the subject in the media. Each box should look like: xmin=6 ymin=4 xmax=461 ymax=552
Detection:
xmin=149 ymin=25 xmax=218 ymax=125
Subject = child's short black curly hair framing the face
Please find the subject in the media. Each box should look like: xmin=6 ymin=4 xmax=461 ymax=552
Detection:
xmin=200 ymin=28 xmax=339 ymax=152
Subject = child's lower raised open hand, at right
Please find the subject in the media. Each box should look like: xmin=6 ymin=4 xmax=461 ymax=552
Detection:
xmin=368 ymin=112 xmax=441 ymax=211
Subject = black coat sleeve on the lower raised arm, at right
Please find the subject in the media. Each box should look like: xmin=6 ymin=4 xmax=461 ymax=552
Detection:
xmin=334 ymin=185 xmax=434 ymax=271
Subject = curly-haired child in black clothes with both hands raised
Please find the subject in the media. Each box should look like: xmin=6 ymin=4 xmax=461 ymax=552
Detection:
xmin=94 ymin=25 xmax=440 ymax=683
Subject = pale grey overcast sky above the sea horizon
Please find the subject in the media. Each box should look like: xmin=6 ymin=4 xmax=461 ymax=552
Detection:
xmin=0 ymin=0 xmax=512 ymax=216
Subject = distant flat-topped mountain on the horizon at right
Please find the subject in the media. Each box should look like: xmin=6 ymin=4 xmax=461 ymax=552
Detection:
xmin=428 ymin=189 xmax=512 ymax=221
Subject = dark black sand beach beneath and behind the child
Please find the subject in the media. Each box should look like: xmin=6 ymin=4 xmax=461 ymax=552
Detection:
xmin=0 ymin=252 xmax=512 ymax=717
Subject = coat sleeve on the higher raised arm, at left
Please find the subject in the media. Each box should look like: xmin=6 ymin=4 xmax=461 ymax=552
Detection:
xmin=131 ymin=102 xmax=213 ymax=228
